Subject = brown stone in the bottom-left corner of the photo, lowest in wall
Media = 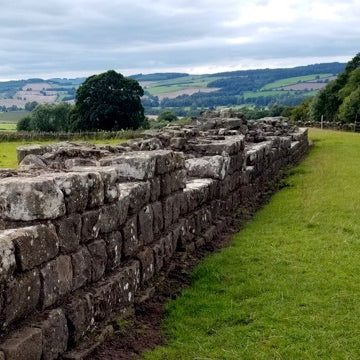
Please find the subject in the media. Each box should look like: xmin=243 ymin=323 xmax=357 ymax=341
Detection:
xmin=0 ymin=327 xmax=42 ymax=360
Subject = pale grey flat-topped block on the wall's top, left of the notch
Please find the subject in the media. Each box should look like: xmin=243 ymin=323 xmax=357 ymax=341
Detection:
xmin=100 ymin=151 xmax=156 ymax=180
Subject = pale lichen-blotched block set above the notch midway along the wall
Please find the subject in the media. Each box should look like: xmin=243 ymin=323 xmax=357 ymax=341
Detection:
xmin=185 ymin=155 xmax=230 ymax=180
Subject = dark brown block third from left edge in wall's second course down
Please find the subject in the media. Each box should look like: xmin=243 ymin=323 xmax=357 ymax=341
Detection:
xmin=55 ymin=214 xmax=82 ymax=254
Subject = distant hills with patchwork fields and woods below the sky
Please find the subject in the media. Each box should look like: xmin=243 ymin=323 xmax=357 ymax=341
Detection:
xmin=0 ymin=63 xmax=346 ymax=115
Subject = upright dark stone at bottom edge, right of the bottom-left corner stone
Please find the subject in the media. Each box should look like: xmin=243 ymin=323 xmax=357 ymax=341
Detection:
xmin=35 ymin=309 xmax=69 ymax=360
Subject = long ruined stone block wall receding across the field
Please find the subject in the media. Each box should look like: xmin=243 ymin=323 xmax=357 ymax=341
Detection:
xmin=0 ymin=111 xmax=308 ymax=360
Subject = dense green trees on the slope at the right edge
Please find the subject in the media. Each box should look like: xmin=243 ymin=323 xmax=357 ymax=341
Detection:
xmin=293 ymin=53 xmax=360 ymax=122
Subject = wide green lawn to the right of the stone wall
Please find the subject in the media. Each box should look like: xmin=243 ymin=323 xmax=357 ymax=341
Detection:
xmin=144 ymin=130 xmax=360 ymax=360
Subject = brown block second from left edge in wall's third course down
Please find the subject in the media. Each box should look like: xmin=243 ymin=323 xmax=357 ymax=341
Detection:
xmin=40 ymin=255 xmax=73 ymax=308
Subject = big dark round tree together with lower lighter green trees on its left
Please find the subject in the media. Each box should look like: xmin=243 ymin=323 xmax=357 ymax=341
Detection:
xmin=17 ymin=70 xmax=146 ymax=132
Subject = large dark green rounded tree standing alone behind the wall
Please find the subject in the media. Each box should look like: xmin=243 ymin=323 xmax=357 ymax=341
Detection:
xmin=72 ymin=70 xmax=145 ymax=130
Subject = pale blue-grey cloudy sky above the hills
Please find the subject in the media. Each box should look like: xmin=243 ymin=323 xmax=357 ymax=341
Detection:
xmin=0 ymin=0 xmax=360 ymax=80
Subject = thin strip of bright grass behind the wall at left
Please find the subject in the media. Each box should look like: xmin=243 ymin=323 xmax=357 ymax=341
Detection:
xmin=0 ymin=139 xmax=127 ymax=168
